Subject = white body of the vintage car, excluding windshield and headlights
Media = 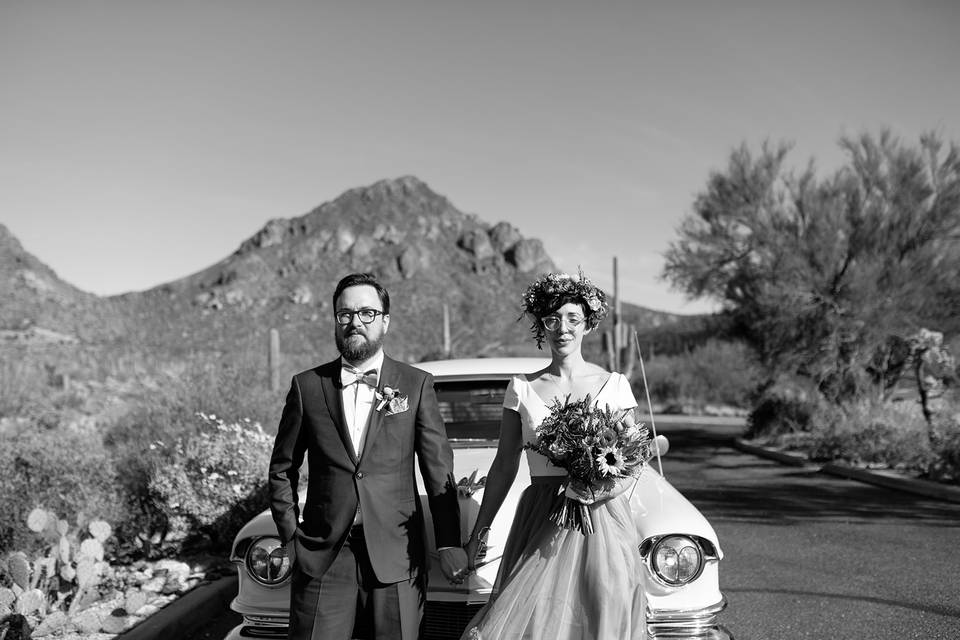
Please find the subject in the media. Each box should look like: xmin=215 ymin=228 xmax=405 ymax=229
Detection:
xmin=228 ymin=358 xmax=730 ymax=640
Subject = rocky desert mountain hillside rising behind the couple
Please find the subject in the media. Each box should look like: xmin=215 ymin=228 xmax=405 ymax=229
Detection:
xmin=0 ymin=177 xmax=704 ymax=372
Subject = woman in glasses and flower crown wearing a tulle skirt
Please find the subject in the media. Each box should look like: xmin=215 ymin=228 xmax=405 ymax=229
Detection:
xmin=462 ymin=273 xmax=644 ymax=640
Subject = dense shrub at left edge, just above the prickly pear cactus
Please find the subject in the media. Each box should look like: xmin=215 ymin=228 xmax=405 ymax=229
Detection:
xmin=0 ymin=425 xmax=122 ymax=551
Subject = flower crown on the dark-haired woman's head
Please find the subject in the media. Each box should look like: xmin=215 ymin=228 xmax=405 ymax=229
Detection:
xmin=520 ymin=270 xmax=609 ymax=348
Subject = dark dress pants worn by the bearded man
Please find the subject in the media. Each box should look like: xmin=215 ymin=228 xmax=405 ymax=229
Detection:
xmin=288 ymin=525 xmax=426 ymax=640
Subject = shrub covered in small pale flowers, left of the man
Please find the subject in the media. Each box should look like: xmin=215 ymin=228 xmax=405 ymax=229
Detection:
xmin=123 ymin=413 xmax=273 ymax=551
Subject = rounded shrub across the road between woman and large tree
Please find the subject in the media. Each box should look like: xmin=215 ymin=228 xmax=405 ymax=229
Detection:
xmin=635 ymin=340 xmax=759 ymax=409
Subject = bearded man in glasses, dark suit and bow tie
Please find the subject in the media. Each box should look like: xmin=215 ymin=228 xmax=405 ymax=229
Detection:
xmin=270 ymin=273 xmax=467 ymax=640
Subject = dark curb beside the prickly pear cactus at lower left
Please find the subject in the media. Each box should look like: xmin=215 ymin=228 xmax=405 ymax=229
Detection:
xmin=114 ymin=575 xmax=237 ymax=640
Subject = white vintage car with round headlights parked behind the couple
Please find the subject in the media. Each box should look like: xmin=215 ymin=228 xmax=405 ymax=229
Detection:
xmin=228 ymin=358 xmax=730 ymax=640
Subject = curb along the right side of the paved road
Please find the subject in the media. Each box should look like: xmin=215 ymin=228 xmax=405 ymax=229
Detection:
xmin=733 ymin=438 xmax=960 ymax=504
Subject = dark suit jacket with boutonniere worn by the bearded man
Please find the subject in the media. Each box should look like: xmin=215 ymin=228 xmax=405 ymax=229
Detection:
xmin=269 ymin=356 xmax=461 ymax=583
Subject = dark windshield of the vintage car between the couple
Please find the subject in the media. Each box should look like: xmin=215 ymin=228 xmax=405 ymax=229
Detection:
xmin=434 ymin=380 xmax=508 ymax=442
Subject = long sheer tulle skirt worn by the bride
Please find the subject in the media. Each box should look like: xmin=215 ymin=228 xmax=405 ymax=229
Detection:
xmin=461 ymin=483 xmax=645 ymax=640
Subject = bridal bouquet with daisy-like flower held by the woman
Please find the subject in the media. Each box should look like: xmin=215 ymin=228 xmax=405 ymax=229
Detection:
xmin=524 ymin=395 xmax=652 ymax=535
